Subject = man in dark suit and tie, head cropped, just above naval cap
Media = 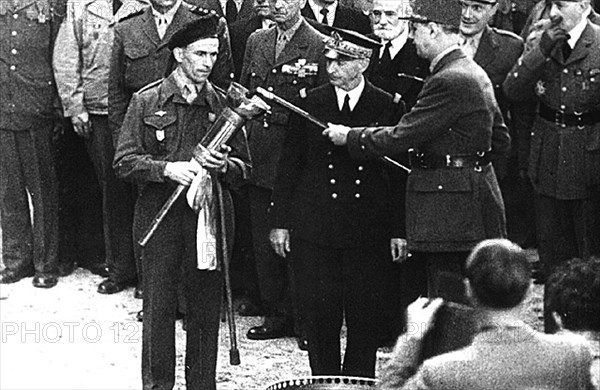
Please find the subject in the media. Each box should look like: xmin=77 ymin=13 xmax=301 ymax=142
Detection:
xmin=302 ymin=0 xmax=371 ymax=34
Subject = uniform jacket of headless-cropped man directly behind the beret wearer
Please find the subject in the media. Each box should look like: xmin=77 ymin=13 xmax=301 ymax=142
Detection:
xmin=108 ymin=2 xmax=233 ymax=134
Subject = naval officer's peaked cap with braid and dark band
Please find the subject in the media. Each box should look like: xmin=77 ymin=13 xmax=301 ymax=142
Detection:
xmin=323 ymin=26 xmax=381 ymax=60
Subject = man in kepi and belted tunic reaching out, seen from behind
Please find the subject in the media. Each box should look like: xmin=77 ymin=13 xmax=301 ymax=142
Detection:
xmin=324 ymin=0 xmax=510 ymax=301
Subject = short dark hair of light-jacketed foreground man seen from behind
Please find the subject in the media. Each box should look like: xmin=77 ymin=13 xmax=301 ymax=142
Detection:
xmin=465 ymin=239 xmax=531 ymax=309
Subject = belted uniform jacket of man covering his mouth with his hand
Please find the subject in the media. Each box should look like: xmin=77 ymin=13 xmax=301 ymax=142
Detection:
xmin=504 ymin=21 xmax=600 ymax=199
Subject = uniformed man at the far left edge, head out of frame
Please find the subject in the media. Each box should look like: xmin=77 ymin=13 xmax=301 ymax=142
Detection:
xmin=0 ymin=0 xmax=64 ymax=288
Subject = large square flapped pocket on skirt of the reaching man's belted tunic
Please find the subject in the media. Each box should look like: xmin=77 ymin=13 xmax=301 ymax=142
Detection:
xmin=406 ymin=169 xmax=484 ymax=242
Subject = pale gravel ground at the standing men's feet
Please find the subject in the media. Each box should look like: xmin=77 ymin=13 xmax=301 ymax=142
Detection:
xmin=0 ymin=251 xmax=542 ymax=390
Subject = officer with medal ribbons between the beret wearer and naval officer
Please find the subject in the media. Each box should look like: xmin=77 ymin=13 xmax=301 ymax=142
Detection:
xmin=240 ymin=0 xmax=326 ymax=340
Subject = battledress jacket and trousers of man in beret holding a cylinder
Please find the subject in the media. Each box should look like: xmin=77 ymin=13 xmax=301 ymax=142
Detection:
xmin=114 ymin=75 xmax=249 ymax=390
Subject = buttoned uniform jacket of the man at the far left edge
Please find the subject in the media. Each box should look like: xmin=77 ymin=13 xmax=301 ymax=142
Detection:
xmin=0 ymin=0 xmax=64 ymax=131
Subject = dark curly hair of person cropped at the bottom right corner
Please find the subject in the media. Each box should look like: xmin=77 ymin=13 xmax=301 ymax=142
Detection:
xmin=545 ymin=257 xmax=600 ymax=332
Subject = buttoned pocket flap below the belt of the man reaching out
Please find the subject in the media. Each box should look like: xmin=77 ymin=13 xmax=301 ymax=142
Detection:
xmin=410 ymin=168 xmax=473 ymax=192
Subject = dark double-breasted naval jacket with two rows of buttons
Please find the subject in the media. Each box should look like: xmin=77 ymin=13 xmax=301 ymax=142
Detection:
xmin=271 ymin=81 xmax=404 ymax=248
